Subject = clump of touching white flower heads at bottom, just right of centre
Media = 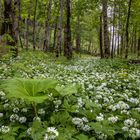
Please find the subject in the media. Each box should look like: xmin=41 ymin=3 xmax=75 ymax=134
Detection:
xmin=72 ymin=117 xmax=90 ymax=132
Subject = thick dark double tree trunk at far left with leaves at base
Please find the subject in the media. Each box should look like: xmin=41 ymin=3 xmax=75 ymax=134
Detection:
xmin=1 ymin=0 xmax=19 ymax=57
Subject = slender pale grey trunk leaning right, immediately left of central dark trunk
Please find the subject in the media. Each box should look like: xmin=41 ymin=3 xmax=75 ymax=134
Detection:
xmin=56 ymin=0 xmax=64 ymax=57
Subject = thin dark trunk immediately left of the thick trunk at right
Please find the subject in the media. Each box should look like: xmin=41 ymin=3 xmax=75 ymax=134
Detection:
xmin=100 ymin=13 xmax=104 ymax=59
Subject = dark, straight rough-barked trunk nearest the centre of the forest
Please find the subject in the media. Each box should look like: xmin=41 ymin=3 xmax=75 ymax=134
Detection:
xmin=64 ymin=0 xmax=72 ymax=59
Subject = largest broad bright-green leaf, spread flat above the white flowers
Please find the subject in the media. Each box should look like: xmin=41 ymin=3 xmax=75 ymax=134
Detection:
xmin=2 ymin=79 xmax=57 ymax=103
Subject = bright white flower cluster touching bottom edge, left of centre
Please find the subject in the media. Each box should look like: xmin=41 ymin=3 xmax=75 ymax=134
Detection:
xmin=44 ymin=127 xmax=59 ymax=140
